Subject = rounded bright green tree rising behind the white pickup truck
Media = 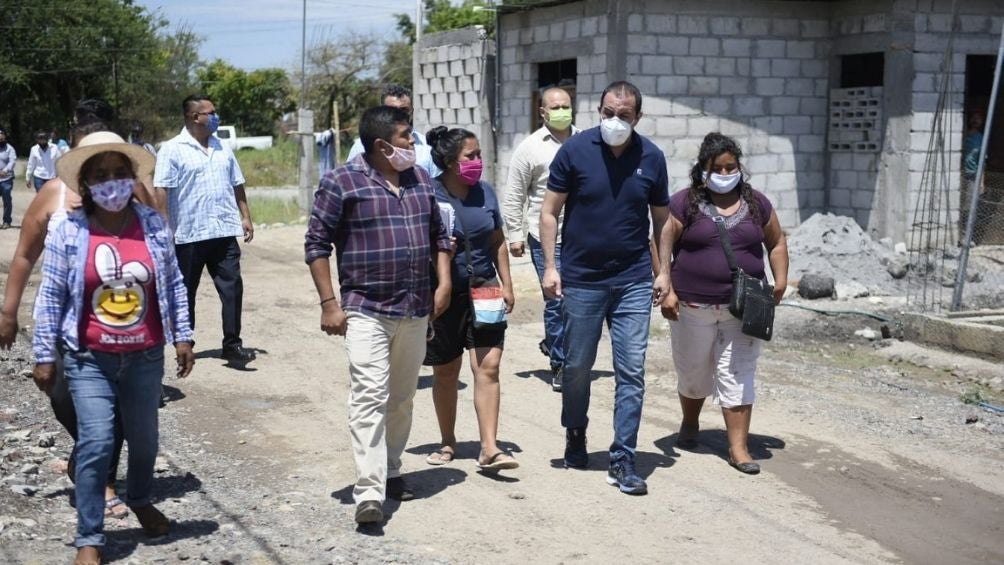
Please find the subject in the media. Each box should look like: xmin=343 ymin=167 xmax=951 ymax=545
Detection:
xmin=196 ymin=59 xmax=296 ymax=135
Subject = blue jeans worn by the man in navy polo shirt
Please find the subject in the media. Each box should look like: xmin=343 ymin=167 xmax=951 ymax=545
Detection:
xmin=561 ymin=280 xmax=652 ymax=463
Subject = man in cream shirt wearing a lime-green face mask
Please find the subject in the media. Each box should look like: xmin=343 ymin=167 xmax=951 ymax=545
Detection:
xmin=502 ymin=87 xmax=578 ymax=391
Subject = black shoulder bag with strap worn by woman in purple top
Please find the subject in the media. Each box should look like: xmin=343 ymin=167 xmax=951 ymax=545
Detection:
xmin=709 ymin=204 xmax=774 ymax=341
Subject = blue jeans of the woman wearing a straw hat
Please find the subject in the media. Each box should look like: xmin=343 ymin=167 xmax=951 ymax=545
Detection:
xmin=65 ymin=345 xmax=164 ymax=547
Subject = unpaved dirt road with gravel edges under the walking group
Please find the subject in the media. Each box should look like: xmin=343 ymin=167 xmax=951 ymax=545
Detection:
xmin=0 ymin=185 xmax=1004 ymax=563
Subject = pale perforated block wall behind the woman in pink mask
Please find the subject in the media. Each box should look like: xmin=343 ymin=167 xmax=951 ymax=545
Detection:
xmin=413 ymin=27 xmax=498 ymax=186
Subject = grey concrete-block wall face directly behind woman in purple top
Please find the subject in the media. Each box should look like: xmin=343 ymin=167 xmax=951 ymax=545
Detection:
xmin=626 ymin=0 xmax=830 ymax=227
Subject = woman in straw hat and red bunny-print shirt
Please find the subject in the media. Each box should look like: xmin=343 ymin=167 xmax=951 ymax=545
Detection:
xmin=34 ymin=131 xmax=194 ymax=563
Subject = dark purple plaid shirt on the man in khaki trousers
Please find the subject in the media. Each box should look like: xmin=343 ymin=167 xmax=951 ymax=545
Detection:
xmin=304 ymin=156 xmax=450 ymax=318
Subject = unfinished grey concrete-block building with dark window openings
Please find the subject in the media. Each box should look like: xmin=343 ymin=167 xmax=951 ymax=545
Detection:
xmin=416 ymin=0 xmax=1004 ymax=241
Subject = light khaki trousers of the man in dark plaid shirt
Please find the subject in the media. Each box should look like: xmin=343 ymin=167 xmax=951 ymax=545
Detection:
xmin=345 ymin=312 xmax=429 ymax=504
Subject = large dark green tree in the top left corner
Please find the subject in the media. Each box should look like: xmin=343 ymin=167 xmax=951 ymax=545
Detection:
xmin=0 ymin=0 xmax=167 ymax=147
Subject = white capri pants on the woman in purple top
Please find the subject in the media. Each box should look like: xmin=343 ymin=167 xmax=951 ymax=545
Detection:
xmin=670 ymin=302 xmax=762 ymax=408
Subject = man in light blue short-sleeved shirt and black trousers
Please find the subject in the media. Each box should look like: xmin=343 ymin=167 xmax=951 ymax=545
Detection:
xmin=154 ymin=94 xmax=255 ymax=363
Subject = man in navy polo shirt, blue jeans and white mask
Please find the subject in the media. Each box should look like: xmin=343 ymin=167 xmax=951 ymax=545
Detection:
xmin=540 ymin=81 xmax=670 ymax=495
